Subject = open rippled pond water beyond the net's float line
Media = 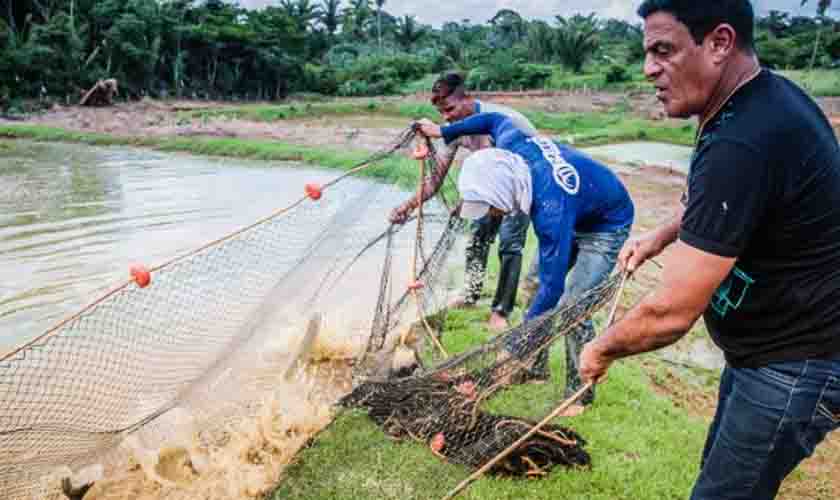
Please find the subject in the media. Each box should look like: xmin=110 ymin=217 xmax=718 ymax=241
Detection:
xmin=0 ymin=141 xmax=420 ymax=351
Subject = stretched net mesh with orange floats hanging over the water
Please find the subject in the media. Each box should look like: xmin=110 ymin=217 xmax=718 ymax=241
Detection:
xmin=0 ymin=129 xmax=462 ymax=500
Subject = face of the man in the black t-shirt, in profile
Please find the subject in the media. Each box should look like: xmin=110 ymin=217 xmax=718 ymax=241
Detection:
xmin=644 ymin=12 xmax=721 ymax=118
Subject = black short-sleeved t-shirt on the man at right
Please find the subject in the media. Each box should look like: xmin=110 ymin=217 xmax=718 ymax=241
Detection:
xmin=680 ymin=70 xmax=840 ymax=367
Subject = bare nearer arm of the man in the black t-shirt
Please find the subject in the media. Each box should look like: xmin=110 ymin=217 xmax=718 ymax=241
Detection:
xmin=580 ymin=241 xmax=735 ymax=381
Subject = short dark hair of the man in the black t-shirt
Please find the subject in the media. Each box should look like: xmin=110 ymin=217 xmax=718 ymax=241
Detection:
xmin=638 ymin=0 xmax=755 ymax=52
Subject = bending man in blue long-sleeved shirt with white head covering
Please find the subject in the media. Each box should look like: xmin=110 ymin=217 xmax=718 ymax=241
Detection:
xmin=420 ymin=113 xmax=634 ymax=414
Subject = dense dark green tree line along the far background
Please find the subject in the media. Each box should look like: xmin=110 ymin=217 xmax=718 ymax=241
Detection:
xmin=0 ymin=0 xmax=840 ymax=105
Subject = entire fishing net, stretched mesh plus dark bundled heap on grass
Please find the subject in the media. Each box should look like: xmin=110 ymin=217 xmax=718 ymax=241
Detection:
xmin=0 ymin=124 xmax=617 ymax=499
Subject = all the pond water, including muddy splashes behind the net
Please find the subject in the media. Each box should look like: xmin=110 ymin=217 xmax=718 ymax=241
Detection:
xmin=0 ymin=142 xmax=466 ymax=500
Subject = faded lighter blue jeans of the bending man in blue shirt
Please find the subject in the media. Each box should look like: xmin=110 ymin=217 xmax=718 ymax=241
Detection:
xmin=512 ymin=227 xmax=630 ymax=405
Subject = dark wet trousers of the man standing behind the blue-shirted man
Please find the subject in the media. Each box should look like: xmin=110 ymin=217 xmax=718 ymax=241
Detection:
xmin=464 ymin=213 xmax=530 ymax=317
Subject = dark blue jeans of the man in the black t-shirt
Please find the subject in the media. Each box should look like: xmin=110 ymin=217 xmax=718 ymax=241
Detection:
xmin=691 ymin=357 xmax=840 ymax=500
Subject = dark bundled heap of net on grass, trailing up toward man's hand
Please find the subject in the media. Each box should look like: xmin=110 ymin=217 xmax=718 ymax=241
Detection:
xmin=340 ymin=275 xmax=622 ymax=476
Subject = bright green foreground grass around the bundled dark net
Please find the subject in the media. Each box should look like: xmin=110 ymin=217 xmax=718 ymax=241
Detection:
xmin=273 ymin=336 xmax=706 ymax=500
